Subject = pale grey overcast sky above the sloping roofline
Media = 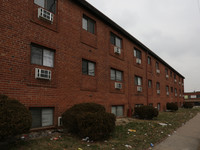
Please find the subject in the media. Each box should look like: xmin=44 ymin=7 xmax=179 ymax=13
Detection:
xmin=87 ymin=0 xmax=200 ymax=92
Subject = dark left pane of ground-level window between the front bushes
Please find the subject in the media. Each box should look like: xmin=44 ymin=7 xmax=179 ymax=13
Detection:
xmin=30 ymin=108 xmax=41 ymax=128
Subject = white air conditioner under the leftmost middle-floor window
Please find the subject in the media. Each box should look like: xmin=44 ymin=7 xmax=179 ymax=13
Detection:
xmin=35 ymin=68 xmax=51 ymax=80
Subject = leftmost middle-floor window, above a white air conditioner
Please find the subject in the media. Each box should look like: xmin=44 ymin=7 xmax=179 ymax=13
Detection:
xmin=31 ymin=44 xmax=54 ymax=67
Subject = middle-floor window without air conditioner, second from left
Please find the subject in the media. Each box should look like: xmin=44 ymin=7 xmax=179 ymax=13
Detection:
xmin=82 ymin=59 xmax=95 ymax=76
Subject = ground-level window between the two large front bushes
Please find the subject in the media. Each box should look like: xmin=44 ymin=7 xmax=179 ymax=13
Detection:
xmin=30 ymin=108 xmax=54 ymax=128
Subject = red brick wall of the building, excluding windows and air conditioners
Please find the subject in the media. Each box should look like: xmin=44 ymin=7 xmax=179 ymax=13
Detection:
xmin=0 ymin=0 xmax=184 ymax=125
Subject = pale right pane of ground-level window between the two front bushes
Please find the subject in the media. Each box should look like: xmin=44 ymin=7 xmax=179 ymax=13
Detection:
xmin=42 ymin=108 xmax=53 ymax=127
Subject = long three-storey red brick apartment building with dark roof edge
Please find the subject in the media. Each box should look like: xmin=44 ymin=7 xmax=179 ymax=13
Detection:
xmin=0 ymin=0 xmax=184 ymax=128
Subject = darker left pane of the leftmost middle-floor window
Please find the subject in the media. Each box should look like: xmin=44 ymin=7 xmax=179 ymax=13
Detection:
xmin=31 ymin=46 xmax=42 ymax=65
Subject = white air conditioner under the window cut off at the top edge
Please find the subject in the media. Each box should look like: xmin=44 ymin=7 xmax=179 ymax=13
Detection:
xmin=38 ymin=8 xmax=54 ymax=23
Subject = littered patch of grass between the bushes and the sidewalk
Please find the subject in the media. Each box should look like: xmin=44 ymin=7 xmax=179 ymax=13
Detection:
xmin=3 ymin=108 xmax=200 ymax=150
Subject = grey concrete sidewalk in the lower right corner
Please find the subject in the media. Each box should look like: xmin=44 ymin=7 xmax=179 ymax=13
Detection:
xmin=153 ymin=113 xmax=200 ymax=150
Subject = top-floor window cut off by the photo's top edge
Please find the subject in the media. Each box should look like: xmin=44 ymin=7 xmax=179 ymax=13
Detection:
xmin=34 ymin=0 xmax=56 ymax=14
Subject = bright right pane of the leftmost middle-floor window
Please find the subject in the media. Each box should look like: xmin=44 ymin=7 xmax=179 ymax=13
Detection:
xmin=43 ymin=49 xmax=54 ymax=67
